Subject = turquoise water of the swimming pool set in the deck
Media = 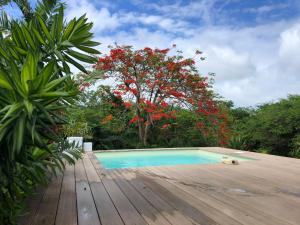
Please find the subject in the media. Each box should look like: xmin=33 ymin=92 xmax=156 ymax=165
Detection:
xmin=95 ymin=150 xmax=249 ymax=169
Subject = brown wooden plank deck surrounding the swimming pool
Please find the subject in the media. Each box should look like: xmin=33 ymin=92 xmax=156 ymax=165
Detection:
xmin=20 ymin=148 xmax=300 ymax=225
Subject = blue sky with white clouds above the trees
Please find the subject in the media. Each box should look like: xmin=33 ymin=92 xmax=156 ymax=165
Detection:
xmin=2 ymin=0 xmax=300 ymax=107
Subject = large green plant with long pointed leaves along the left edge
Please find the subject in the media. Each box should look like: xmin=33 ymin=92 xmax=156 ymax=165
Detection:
xmin=0 ymin=0 xmax=98 ymax=224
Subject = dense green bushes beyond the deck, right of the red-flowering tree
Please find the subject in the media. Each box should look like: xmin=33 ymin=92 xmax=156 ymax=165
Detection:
xmin=229 ymin=95 xmax=300 ymax=158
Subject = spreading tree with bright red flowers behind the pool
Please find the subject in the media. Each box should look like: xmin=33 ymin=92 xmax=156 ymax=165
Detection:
xmin=94 ymin=46 xmax=229 ymax=145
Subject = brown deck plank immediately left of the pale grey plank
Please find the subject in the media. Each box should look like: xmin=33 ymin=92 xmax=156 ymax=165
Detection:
xmin=55 ymin=165 xmax=77 ymax=225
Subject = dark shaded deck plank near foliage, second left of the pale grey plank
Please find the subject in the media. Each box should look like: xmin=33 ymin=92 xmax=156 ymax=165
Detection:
xmin=32 ymin=175 xmax=62 ymax=225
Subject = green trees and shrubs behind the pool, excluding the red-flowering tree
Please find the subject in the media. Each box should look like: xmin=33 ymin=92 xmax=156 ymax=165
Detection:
xmin=65 ymin=89 xmax=300 ymax=157
